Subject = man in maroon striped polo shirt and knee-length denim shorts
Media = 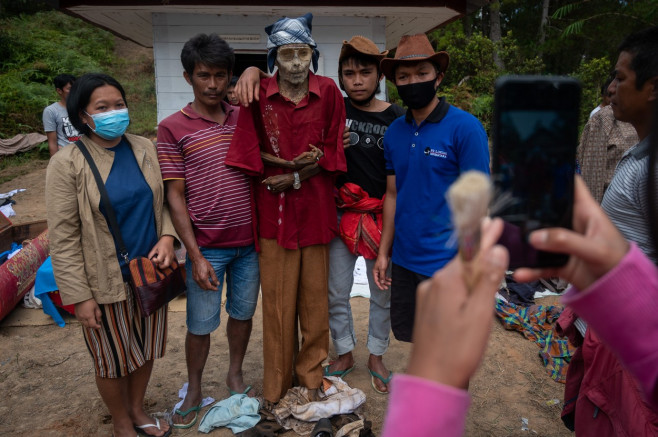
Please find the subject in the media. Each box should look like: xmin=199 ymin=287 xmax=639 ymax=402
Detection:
xmin=158 ymin=34 xmax=260 ymax=428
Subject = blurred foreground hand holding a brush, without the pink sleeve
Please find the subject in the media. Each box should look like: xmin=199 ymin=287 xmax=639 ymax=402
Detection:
xmin=407 ymin=219 xmax=509 ymax=388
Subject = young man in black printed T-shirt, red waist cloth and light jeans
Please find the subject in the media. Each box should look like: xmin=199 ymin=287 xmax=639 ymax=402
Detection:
xmin=325 ymin=36 xmax=405 ymax=393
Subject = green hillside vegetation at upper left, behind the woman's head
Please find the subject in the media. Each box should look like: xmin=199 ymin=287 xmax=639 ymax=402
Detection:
xmin=0 ymin=11 xmax=114 ymax=136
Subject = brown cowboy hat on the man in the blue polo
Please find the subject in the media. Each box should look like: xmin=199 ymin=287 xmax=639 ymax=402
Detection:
xmin=381 ymin=33 xmax=450 ymax=82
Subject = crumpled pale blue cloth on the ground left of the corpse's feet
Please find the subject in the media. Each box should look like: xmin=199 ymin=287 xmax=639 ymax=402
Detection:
xmin=199 ymin=394 xmax=260 ymax=434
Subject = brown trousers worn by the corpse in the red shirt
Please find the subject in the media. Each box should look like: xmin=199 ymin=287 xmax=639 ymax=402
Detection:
xmin=259 ymin=238 xmax=329 ymax=403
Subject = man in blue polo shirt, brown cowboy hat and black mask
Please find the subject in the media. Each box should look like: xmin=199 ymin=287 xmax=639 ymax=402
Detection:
xmin=373 ymin=34 xmax=489 ymax=341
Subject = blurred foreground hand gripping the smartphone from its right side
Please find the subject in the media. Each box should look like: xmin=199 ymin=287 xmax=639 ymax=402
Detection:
xmin=514 ymin=176 xmax=630 ymax=290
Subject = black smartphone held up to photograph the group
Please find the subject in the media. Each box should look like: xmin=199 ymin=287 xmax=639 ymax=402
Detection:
xmin=492 ymin=76 xmax=581 ymax=269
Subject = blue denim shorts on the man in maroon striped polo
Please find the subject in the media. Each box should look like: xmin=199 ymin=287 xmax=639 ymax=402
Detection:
xmin=185 ymin=244 xmax=260 ymax=335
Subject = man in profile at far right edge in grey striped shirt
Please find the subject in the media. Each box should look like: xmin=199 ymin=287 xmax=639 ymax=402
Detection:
xmin=601 ymin=27 xmax=658 ymax=262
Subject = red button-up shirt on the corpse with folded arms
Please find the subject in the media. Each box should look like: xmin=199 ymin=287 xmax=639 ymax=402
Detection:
xmin=226 ymin=73 xmax=347 ymax=249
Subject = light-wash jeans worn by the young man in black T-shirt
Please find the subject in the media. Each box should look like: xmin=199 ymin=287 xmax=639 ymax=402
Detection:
xmin=329 ymin=214 xmax=391 ymax=355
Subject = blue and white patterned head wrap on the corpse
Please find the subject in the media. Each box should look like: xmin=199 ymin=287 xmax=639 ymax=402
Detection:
xmin=265 ymin=12 xmax=320 ymax=72
